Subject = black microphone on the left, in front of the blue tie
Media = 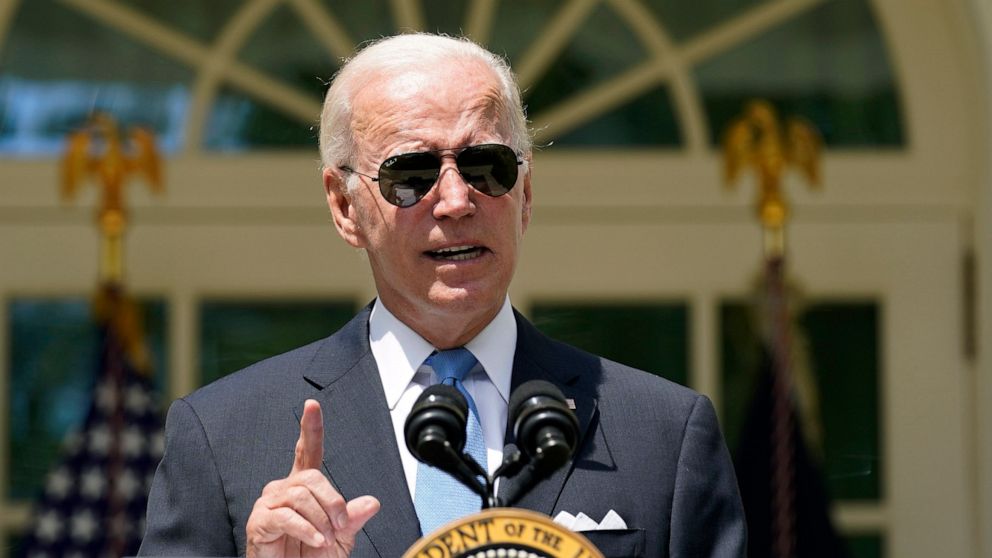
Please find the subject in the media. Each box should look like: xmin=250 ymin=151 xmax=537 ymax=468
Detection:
xmin=403 ymin=384 xmax=488 ymax=505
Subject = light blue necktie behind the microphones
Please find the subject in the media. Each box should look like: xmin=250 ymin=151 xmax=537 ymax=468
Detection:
xmin=414 ymin=348 xmax=486 ymax=535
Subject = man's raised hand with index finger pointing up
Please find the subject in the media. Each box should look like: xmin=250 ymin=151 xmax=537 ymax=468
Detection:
xmin=246 ymin=399 xmax=379 ymax=558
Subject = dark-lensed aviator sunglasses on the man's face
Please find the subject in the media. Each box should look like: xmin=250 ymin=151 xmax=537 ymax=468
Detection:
xmin=338 ymin=143 xmax=523 ymax=207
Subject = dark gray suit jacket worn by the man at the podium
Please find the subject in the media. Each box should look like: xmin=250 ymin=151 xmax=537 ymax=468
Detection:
xmin=140 ymin=308 xmax=746 ymax=558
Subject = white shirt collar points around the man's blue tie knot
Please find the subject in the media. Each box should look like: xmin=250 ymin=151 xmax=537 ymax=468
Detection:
xmin=369 ymin=296 xmax=517 ymax=410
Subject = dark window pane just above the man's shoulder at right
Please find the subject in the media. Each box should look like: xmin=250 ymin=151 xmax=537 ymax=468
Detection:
xmin=530 ymin=302 xmax=689 ymax=385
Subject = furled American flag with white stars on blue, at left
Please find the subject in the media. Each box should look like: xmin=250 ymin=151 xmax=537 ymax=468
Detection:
xmin=21 ymin=288 xmax=164 ymax=558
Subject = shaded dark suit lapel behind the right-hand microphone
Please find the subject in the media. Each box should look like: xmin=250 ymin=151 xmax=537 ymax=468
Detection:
xmin=499 ymin=314 xmax=596 ymax=515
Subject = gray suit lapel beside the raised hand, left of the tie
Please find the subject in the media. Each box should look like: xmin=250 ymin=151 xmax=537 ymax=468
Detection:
xmin=296 ymin=308 xmax=420 ymax=557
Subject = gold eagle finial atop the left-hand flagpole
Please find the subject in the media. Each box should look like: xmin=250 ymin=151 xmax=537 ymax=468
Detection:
xmin=62 ymin=113 xmax=164 ymax=283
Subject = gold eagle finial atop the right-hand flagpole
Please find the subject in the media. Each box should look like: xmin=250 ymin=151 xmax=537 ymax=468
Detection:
xmin=723 ymin=100 xmax=823 ymax=254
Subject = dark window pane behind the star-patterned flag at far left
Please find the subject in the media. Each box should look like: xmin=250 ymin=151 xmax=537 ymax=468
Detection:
xmin=4 ymin=298 xmax=168 ymax=500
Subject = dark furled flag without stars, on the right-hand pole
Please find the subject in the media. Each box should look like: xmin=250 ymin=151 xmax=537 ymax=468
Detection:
xmin=734 ymin=258 xmax=849 ymax=558
